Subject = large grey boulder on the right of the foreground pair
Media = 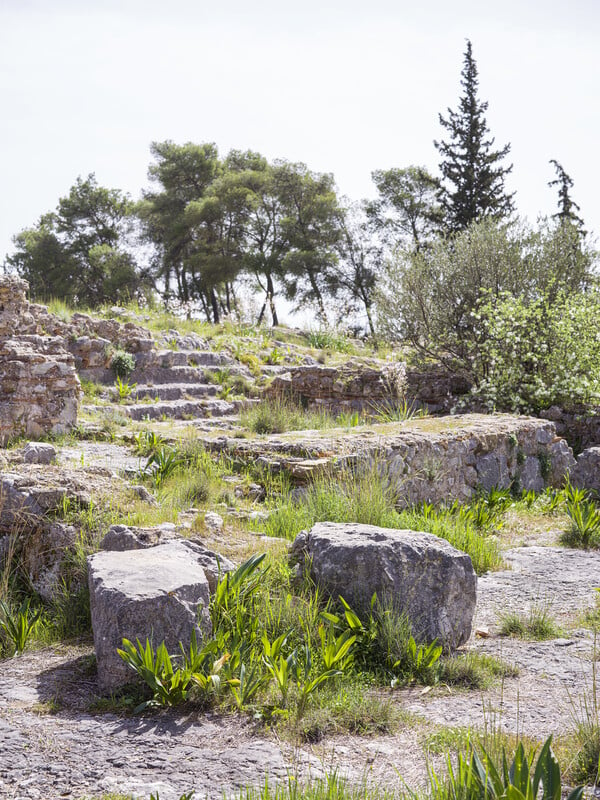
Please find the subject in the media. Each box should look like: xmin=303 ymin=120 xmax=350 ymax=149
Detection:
xmin=290 ymin=522 xmax=477 ymax=648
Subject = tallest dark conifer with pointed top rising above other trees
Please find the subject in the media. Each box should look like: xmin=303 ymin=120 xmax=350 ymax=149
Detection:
xmin=434 ymin=40 xmax=514 ymax=232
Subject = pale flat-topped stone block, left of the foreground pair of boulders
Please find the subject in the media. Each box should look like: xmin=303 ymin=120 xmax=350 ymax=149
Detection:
xmin=88 ymin=542 xmax=210 ymax=691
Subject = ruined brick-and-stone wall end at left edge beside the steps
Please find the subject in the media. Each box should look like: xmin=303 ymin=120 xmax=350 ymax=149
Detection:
xmin=0 ymin=276 xmax=81 ymax=444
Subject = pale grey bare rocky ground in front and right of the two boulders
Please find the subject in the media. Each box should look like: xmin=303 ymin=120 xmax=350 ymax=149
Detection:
xmin=0 ymin=547 xmax=600 ymax=800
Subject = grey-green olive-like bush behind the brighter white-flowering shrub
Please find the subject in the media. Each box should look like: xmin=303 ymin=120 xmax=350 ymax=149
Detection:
xmin=376 ymin=219 xmax=593 ymax=370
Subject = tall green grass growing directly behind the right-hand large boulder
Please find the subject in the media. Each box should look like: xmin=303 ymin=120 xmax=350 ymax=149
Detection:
xmin=263 ymin=467 xmax=503 ymax=575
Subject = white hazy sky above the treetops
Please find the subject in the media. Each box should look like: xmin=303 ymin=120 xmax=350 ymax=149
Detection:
xmin=0 ymin=0 xmax=600 ymax=261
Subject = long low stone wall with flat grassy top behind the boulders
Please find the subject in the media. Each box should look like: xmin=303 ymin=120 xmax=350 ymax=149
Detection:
xmin=202 ymin=414 xmax=575 ymax=506
